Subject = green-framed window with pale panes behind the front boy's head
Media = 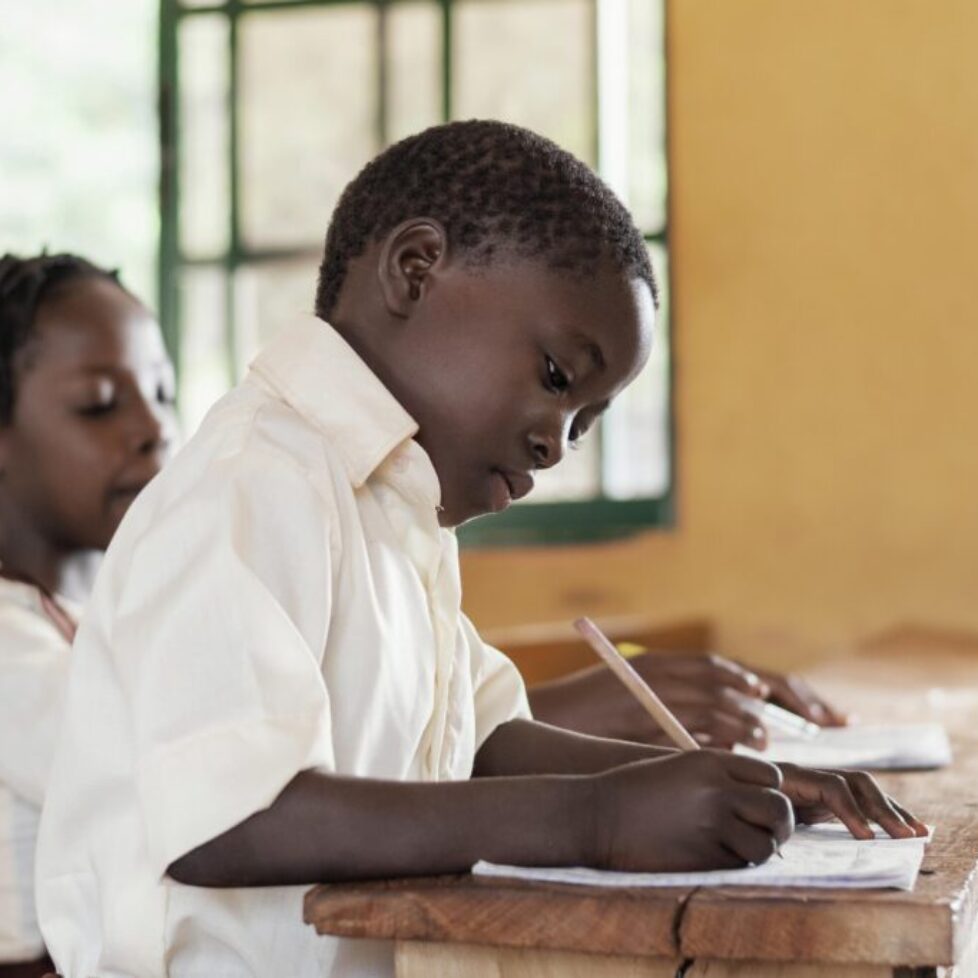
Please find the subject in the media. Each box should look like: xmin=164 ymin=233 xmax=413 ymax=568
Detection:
xmin=160 ymin=0 xmax=671 ymax=545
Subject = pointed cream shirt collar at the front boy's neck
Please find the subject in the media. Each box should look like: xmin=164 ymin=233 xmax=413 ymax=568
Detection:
xmin=250 ymin=316 xmax=418 ymax=489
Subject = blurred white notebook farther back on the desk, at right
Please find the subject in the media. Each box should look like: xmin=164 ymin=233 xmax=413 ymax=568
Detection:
xmin=735 ymin=723 xmax=951 ymax=771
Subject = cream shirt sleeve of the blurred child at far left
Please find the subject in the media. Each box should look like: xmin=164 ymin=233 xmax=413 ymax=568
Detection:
xmin=0 ymin=602 xmax=70 ymax=807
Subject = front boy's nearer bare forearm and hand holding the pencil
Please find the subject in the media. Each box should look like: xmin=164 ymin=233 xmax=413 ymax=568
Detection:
xmin=168 ymin=748 xmax=792 ymax=886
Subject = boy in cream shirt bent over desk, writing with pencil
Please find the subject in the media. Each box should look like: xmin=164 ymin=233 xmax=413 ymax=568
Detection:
xmin=32 ymin=122 xmax=917 ymax=978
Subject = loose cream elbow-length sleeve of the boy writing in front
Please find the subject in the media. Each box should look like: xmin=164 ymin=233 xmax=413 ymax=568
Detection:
xmin=109 ymin=442 xmax=336 ymax=875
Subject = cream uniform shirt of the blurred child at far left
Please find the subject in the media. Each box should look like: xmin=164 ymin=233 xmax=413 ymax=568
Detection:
xmin=0 ymin=578 xmax=80 ymax=963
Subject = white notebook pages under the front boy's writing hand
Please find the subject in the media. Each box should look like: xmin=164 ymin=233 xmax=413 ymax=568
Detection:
xmin=472 ymin=822 xmax=933 ymax=890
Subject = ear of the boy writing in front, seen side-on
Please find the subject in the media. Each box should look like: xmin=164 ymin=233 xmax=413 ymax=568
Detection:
xmin=377 ymin=217 xmax=448 ymax=318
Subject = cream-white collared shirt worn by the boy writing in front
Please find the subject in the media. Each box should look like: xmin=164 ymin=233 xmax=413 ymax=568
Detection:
xmin=37 ymin=320 xmax=528 ymax=978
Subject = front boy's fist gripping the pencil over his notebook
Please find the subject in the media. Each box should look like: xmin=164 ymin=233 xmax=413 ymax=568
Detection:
xmin=593 ymin=750 xmax=794 ymax=873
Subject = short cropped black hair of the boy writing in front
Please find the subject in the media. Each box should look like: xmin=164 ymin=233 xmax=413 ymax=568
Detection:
xmin=316 ymin=120 xmax=659 ymax=319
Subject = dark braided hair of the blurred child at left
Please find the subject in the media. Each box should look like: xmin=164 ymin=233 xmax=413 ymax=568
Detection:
xmin=0 ymin=252 xmax=129 ymax=424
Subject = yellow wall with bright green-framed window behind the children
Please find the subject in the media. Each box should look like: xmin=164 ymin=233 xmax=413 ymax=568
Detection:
xmin=0 ymin=0 xmax=978 ymax=666
